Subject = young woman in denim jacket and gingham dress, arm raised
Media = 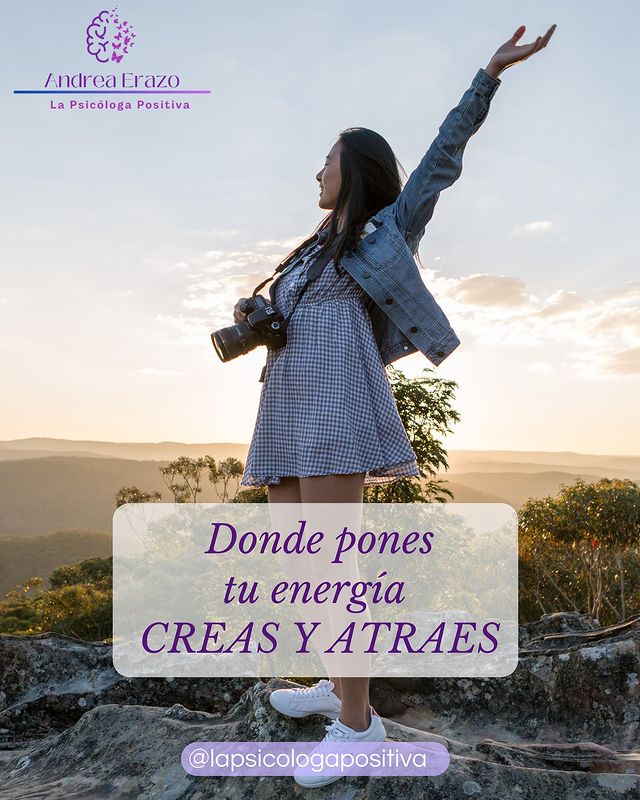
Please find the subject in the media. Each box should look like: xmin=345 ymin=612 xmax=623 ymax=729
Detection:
xmin=234 ymin=25 xmax=556 ymax=786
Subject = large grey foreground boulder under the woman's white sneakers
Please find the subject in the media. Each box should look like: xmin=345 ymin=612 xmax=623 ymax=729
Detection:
xmin=0 ymin=679 xmax=640 ymax=800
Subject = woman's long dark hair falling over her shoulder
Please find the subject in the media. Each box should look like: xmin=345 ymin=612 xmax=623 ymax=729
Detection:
xmin=284 ymin=127 xmax=420 ymax=271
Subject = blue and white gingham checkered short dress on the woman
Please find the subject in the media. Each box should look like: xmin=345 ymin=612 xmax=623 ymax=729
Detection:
xmin=240 ymin=225 xmax=420 ymax=486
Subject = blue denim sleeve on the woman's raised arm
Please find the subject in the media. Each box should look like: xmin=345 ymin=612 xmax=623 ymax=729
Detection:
xmin=393 ymin=68 xmax=502 ymax=240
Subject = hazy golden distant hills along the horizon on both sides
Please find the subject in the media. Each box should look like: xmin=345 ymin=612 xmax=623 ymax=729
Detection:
xmin=0 ymin=438 xmax=640 ymax=536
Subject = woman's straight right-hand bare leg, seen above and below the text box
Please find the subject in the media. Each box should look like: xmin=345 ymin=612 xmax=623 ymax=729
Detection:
xmin=298 ymin=472 xmax=371 ymax=731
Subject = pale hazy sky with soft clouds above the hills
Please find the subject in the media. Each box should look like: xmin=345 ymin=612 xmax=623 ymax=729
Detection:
xmin=0 ymin=0 xmax=640 ymax=455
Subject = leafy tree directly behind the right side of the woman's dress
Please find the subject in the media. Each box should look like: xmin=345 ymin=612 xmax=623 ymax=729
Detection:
xmin=364 ymin=366 xmax=460 ymax=503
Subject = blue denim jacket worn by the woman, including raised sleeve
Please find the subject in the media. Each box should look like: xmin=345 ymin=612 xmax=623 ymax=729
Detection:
xmin=340 ymin=68 xmax=502 ymax=366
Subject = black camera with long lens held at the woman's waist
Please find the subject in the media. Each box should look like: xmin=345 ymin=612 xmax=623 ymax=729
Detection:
xmin=211 ymin=295 xmax=287 ymax=361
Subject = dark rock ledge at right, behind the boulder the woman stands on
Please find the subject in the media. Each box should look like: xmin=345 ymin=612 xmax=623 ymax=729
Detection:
xmin=371 ymin=614 xmax=640 ymax=750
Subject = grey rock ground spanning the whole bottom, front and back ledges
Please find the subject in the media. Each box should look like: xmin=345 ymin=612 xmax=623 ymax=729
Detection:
xmin=0 ymin=615 xmax=640 ymax=800
